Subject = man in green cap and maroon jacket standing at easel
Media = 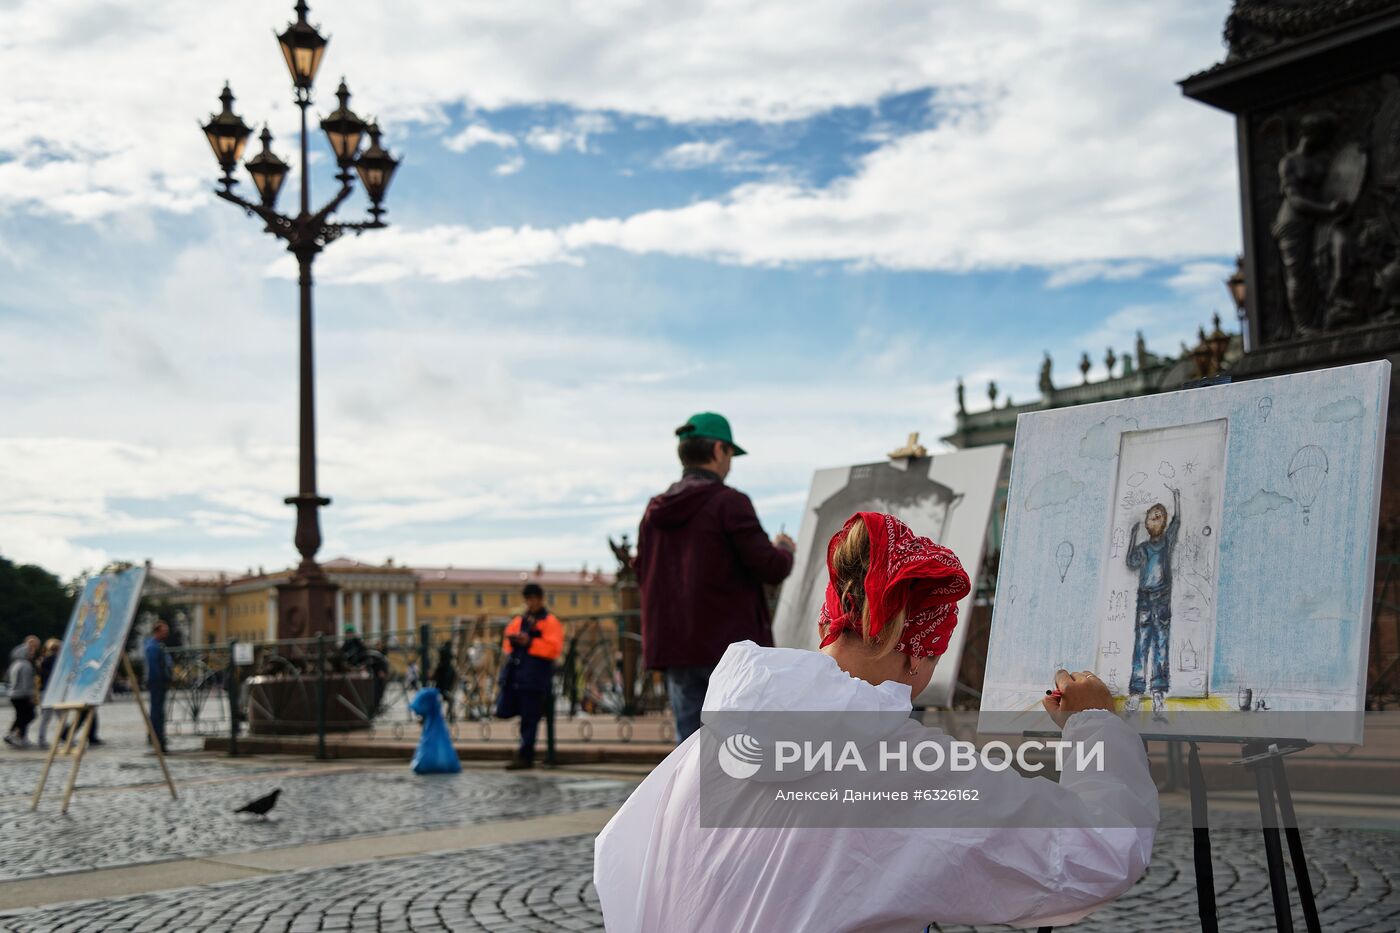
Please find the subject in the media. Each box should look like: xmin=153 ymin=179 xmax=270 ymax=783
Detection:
xmin=636 ymin=412 xmax=797 ymax=742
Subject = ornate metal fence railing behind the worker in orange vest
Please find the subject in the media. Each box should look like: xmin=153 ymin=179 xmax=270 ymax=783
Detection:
xmin=151 ymin=611 xmax=675 ymax=754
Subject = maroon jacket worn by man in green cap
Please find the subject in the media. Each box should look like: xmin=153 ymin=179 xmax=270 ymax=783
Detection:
xmin=636 ymin=469 xmax=792 ymax=668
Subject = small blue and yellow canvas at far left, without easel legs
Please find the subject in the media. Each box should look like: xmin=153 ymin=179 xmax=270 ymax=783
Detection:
xmin=43 ymin=567 xmax=146 ymax=707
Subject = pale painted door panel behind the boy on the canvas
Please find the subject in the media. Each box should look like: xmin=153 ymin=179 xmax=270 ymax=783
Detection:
xmin=1095 ymin=419 xmax=1226 ymax=698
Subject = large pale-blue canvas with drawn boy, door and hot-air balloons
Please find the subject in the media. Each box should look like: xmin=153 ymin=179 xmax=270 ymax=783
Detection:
xmin=979 ymin=361 xmax=1390 ymax=744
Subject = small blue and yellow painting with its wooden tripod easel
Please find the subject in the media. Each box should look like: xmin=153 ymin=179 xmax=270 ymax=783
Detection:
xmin=31 ymin=567 xmax=175 ymax=813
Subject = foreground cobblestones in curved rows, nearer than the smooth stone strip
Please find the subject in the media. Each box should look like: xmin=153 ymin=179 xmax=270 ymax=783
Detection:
xmin=0 ymin=828 xmax=1400 ymax=933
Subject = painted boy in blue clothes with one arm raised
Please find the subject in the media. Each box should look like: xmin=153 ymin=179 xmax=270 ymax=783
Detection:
xmin=1127 ymin=486 xmax=1182 ymax=713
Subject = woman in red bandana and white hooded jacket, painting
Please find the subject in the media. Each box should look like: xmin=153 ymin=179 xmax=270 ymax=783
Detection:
xmin=594 ymin=513 xmax=1158 ymax=933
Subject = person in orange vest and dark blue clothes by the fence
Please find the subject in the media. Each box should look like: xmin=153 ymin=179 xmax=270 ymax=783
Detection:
xmin=496 ymin=583 xmax=564 ymax=770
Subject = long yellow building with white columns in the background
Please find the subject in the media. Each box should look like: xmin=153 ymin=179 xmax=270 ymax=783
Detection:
xmin=146 ymin=558 xmax=617 ymax=644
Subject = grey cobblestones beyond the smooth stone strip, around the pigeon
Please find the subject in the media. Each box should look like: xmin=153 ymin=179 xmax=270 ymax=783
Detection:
xmin=0 ymin=705 xmax=631 ymax=881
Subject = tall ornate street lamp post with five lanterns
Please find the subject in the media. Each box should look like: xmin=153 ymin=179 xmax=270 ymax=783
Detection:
xmin=203 ymin=1 xmax=398 ymax=637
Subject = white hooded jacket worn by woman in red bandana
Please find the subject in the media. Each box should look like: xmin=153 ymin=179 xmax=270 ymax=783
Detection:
xmin=594 ymin=642 xmax=1158 ymax=933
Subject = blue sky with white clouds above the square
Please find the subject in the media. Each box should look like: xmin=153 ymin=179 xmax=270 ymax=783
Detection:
xmin=0 ymin=0 xmax=1239 ymax=576
